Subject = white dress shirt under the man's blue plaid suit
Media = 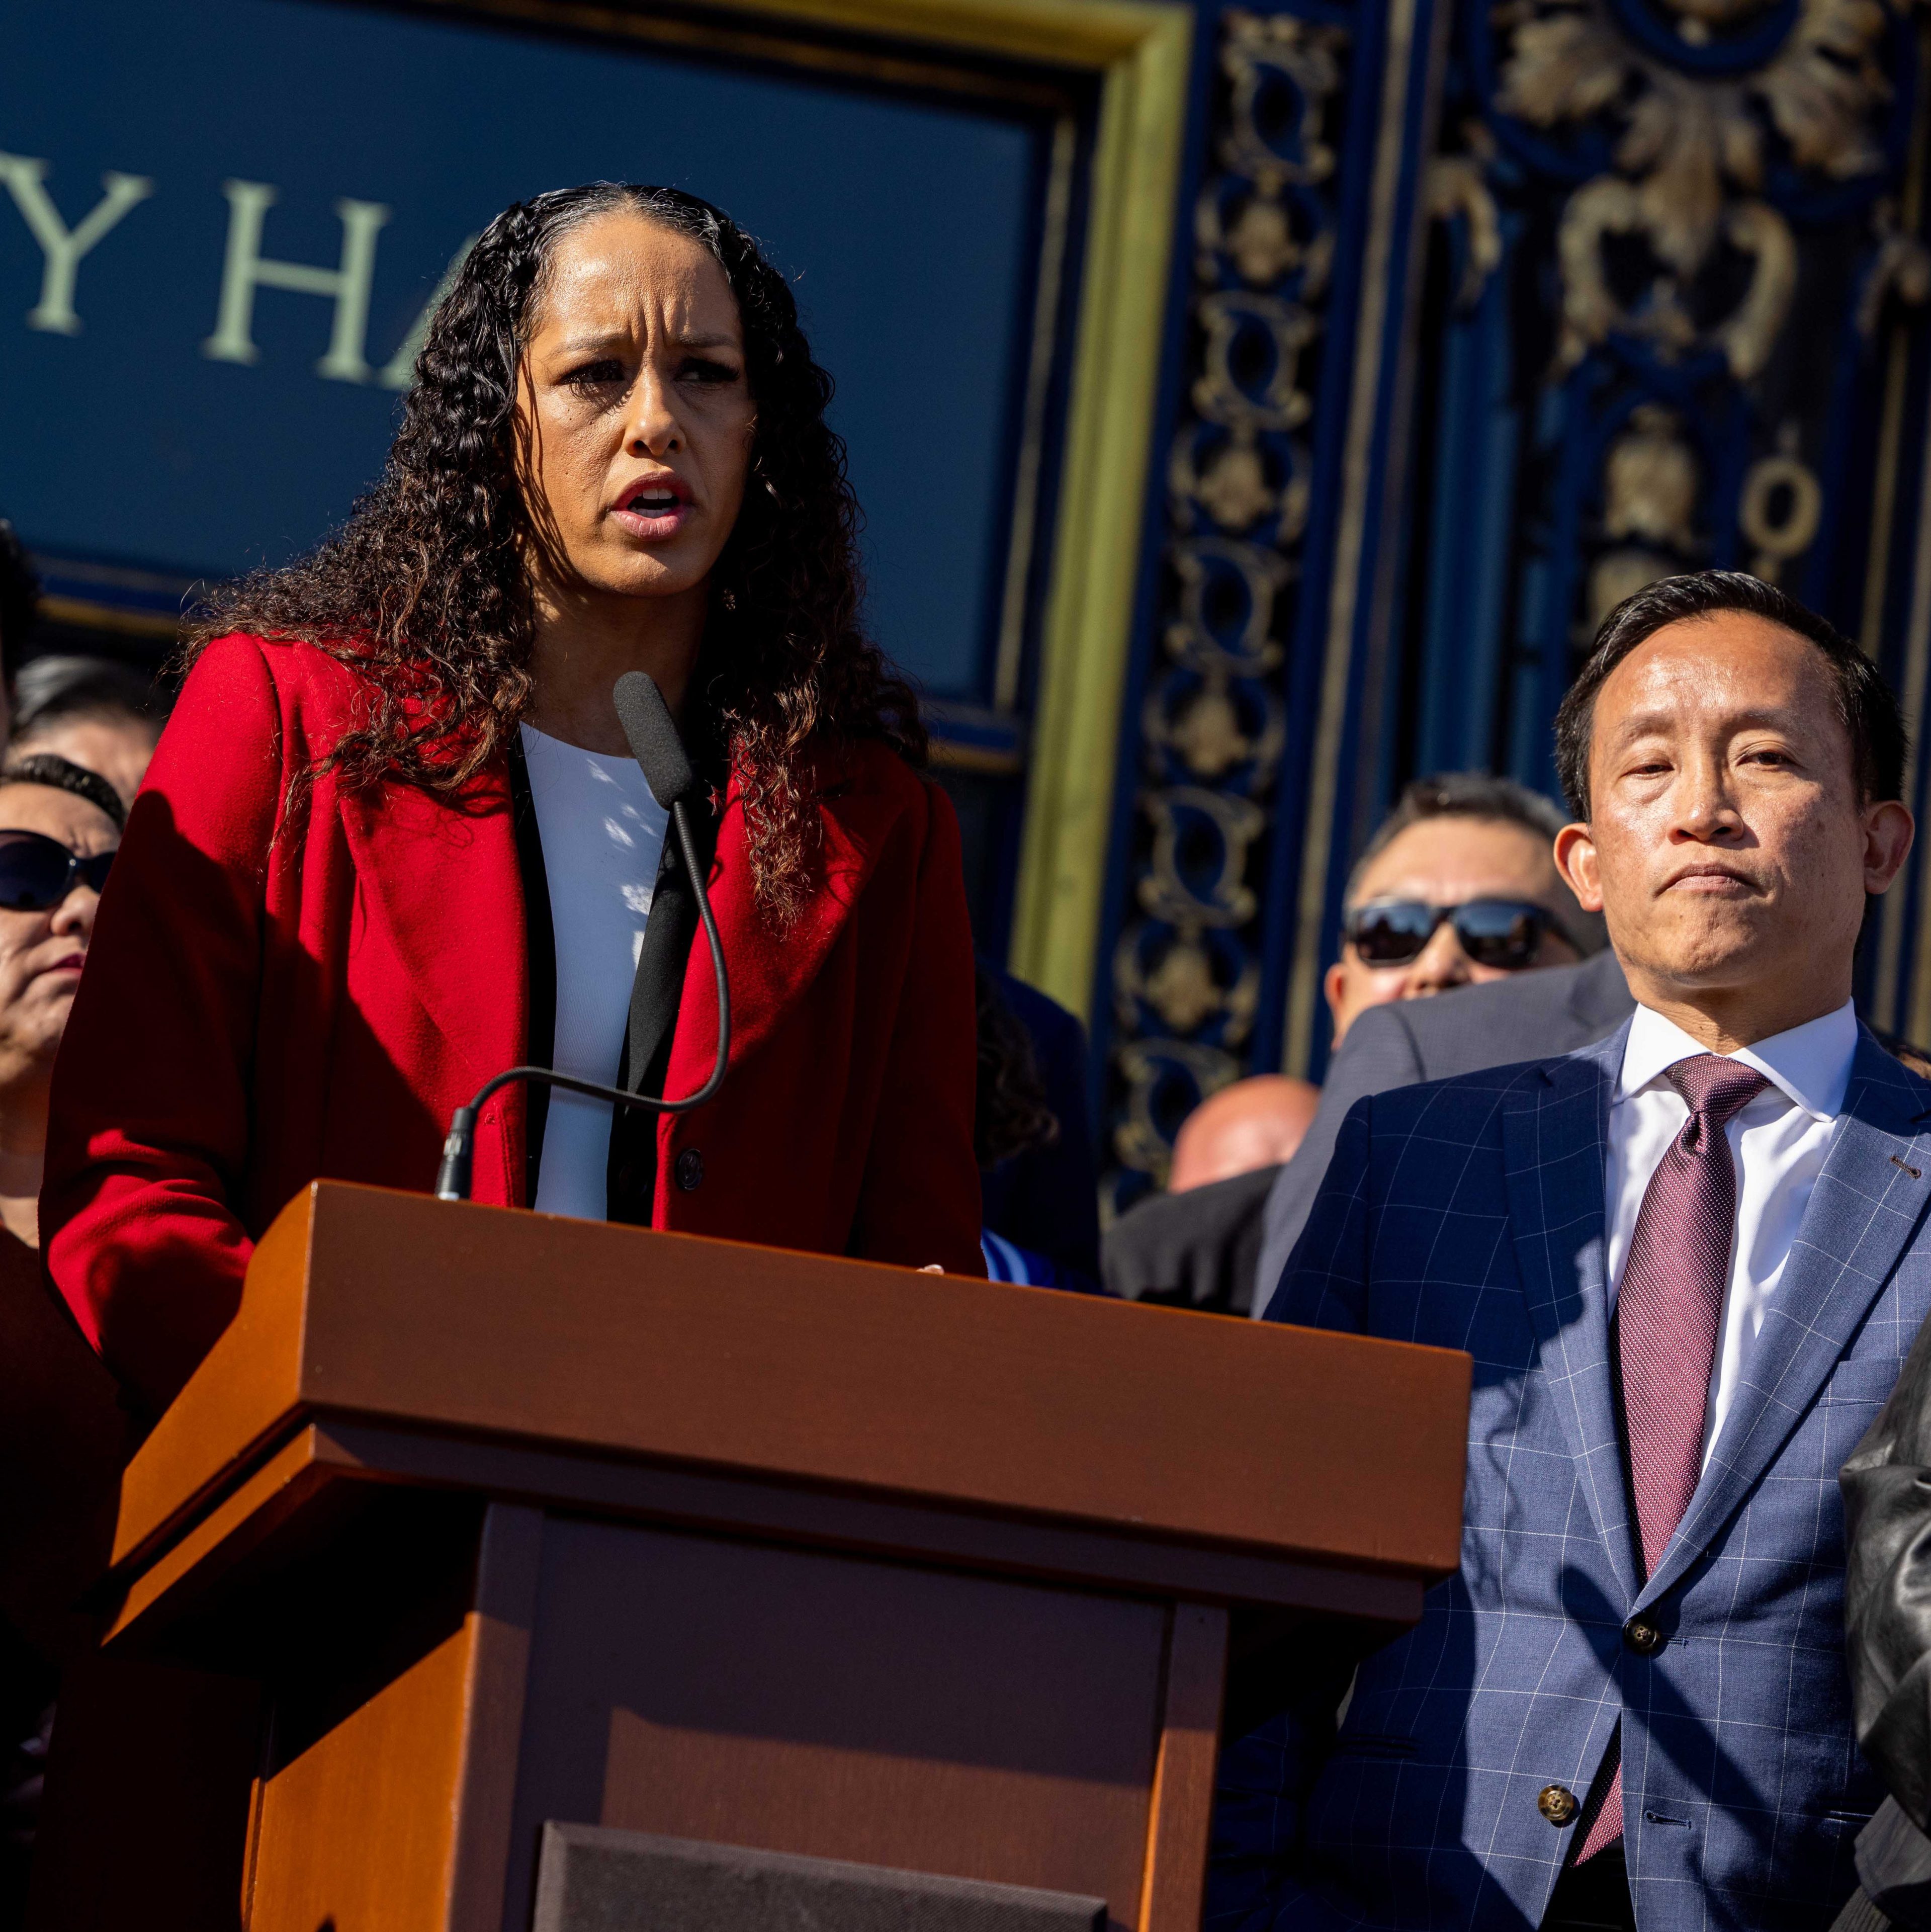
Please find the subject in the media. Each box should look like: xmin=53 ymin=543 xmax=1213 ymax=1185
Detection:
xmin=1605 ymin=1001 xmax=1858 ymax=1466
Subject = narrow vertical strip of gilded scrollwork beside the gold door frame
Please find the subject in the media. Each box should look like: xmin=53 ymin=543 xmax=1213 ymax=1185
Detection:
xmin=1104 ymin=10 xmax=1350 ymax=1211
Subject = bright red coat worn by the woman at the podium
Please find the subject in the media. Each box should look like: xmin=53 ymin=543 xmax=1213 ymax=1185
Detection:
xmin=41 ymin=638 xmax=985 ymax=1406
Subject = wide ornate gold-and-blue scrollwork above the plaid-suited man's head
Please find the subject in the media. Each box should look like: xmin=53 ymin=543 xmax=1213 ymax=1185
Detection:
xmin=1427 ymin=0 xmax=1931 ymax=753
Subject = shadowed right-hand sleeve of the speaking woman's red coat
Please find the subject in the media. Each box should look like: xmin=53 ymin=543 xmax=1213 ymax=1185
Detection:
xmin=851 ymin=783 xmax=985 ymax=1275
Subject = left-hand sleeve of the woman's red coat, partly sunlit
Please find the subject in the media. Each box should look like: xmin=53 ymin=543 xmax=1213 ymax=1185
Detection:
xmin=41 ymin=638 xmax=282 ymax=1410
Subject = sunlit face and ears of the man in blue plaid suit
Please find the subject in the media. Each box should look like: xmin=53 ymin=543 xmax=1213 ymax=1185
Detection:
xmin=1558 ymin=611 xmax=1912 ymax=1011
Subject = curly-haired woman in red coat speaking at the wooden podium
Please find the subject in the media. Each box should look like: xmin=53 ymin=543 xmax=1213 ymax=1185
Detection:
xmin=41 ymin=184 xmax=983 ymax=1408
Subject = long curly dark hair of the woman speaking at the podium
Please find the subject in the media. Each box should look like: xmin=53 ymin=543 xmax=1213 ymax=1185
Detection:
xmin=187 ymin=182 xmax=925 ymax=926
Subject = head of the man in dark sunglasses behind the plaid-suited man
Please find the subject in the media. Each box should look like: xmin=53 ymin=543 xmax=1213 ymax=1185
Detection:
xmin=1327 ymin=773 xmax=1586 ymax=1043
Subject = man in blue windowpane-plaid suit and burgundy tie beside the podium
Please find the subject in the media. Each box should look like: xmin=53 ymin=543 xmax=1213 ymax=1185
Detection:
xmin=1207 ymin=572 xmax=1931 ymax=1932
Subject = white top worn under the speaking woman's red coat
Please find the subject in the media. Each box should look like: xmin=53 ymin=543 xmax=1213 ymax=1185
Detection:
xmin=523 ymin=724 xmax=670 ymax=1221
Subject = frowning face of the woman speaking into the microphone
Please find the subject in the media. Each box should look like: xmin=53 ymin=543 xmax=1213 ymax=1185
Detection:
xmin=517 ymin=211 xmax=757 ymax=597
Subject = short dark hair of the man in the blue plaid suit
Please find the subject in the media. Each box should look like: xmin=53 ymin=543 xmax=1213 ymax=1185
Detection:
xmin=1556 ymin=570 xmax=1906 ymax=819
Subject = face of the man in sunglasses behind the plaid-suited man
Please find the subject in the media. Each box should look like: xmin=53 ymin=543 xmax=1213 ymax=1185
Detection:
xmin=1327 ymin=815 xmax=1579 ymax=1041
